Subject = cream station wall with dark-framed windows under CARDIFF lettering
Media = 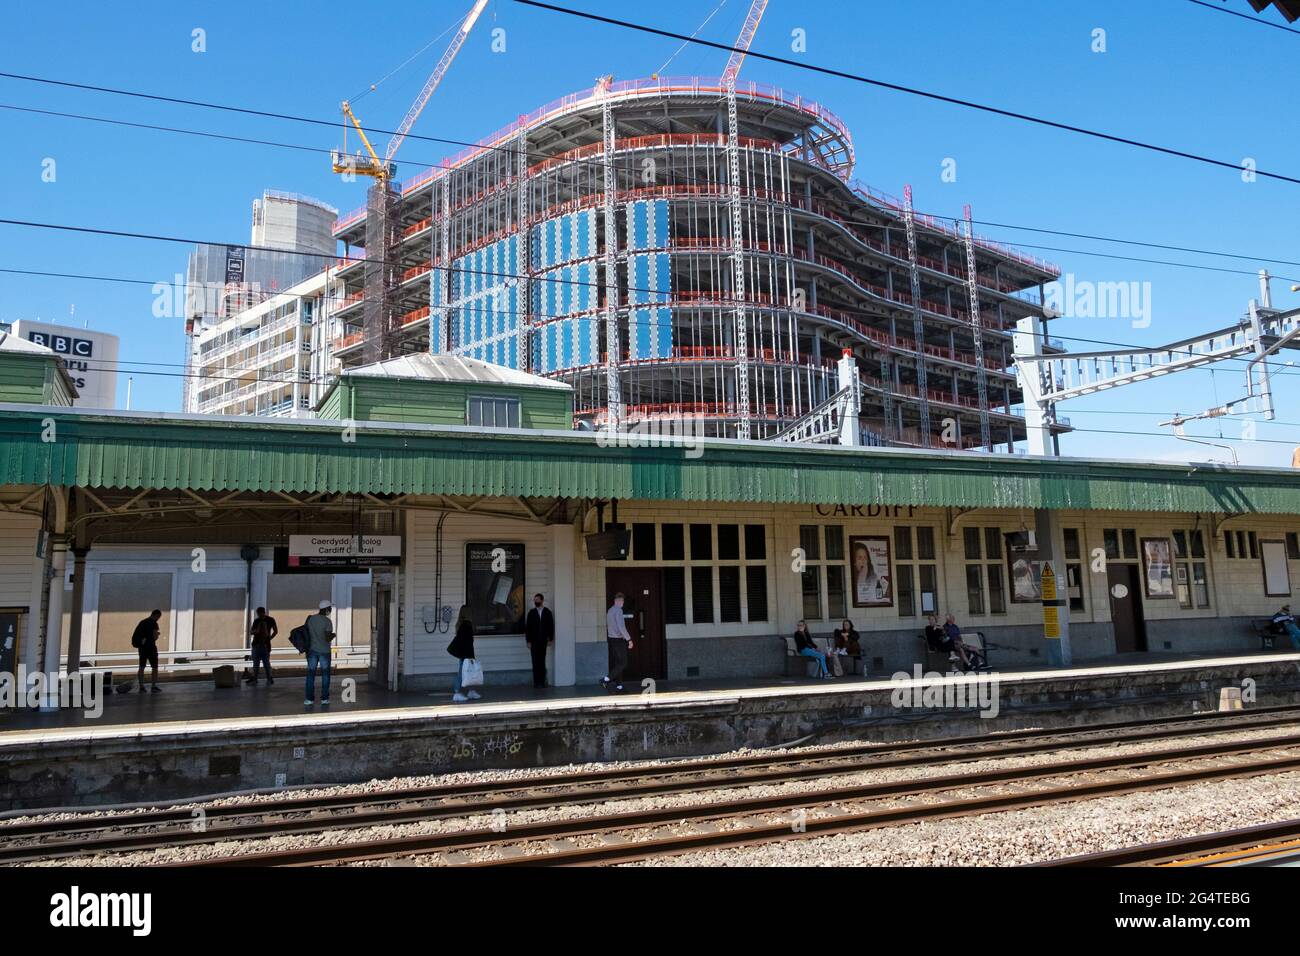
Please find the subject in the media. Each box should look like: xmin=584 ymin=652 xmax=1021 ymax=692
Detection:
xmin=449 ymin=501 xmax=1300 ymax=682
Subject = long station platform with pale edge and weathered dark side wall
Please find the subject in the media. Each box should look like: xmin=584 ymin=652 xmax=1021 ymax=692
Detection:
xmin=0 ymin=652 xmax=1300 ymax=810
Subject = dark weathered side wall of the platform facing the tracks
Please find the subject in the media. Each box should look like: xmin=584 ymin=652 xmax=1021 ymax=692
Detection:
xmin=0 ymin=657 xmax=1300 ymax=810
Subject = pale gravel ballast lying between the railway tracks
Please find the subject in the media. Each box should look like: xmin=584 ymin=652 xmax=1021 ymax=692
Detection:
xmin=15 ymin=727 xmax=1300 ymax=866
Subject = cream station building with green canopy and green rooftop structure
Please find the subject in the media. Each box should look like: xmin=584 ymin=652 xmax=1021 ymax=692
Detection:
xmin=0 ymin=354 xmax=1300 ymax=693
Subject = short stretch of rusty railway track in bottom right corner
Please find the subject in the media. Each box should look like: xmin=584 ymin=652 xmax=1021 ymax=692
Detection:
xmin=1035 ymin=819 xmax=1300 ymax=866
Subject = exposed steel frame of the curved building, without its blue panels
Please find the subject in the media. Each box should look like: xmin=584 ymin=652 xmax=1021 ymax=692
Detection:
xmin=327 ymin=85 xmax=1045 ymax=447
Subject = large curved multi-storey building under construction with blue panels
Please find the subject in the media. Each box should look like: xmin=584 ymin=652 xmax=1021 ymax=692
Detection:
xmin=333 ymin=78 xmax=1058 ymax=447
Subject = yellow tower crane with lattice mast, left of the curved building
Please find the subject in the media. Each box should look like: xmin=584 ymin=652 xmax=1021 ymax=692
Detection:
xmin=330 ymin=0 xmax=488 ymax=362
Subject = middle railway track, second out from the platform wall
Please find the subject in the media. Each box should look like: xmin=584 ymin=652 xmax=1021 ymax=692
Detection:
xmin=181 ymin=735 xmax=1300 ymax=866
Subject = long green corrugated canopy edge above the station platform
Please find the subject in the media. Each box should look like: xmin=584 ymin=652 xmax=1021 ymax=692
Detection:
xmin=0 ymin=405 xmax=1300 ymax=514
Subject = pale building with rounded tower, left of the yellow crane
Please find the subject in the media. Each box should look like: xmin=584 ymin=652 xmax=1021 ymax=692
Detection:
xmin=182 ymin=190 xmax=338 ymax=415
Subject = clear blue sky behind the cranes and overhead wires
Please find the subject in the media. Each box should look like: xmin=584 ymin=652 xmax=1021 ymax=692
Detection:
xmin=0 ymin=0 xmax=1300 ymax=464
